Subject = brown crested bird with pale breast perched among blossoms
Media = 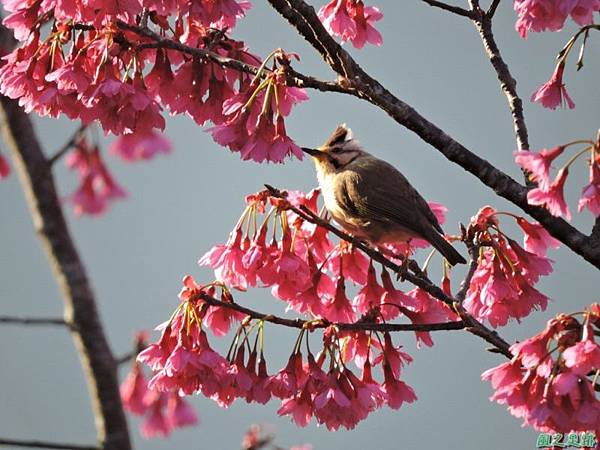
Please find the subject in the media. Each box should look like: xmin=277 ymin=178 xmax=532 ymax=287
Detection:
xmin=302 ymin=124 xmax=466 ymax=266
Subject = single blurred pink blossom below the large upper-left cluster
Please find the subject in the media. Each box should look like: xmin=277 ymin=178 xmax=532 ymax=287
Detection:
xmin=109 ymin=130 xmax=171 ymax=162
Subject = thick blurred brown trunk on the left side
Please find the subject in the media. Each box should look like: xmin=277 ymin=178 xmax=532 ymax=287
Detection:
xmin=0 ymin=97 xmax=131 ymax=450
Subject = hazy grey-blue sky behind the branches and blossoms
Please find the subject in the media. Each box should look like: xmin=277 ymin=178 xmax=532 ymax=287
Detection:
xmin=0 ymin=0 xmax=600 ymax=450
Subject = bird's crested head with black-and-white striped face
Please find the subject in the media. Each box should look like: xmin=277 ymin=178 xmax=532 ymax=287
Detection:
xmin=302 ymin=124 xmax=368 ymax=173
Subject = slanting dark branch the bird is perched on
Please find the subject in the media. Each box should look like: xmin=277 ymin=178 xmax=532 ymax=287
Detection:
xmin=266 ymin=185 xmax=512 ymax=358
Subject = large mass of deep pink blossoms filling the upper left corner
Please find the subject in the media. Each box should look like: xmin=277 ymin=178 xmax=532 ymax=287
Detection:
xmin=0 ymin=0 xmax=306 ymax=162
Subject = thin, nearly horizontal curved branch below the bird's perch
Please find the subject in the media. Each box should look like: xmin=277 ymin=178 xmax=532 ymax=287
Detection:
xmin=198 ymin=294 xmax=465 ymax=332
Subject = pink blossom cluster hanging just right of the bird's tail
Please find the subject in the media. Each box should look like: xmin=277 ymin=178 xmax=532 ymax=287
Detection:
xmin=464 ymin=206 xmax=558 ymax=327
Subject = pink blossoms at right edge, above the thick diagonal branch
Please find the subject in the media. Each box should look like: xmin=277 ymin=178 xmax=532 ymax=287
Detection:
xmin=515 ymin=135 xmax=600 ymax=220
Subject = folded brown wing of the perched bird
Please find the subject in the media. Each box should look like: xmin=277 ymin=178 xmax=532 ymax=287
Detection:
xmin=336 ymin=158 xmax=443 ymax=236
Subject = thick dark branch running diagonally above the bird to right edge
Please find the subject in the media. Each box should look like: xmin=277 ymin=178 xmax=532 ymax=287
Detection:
xmin=269 ymin=0 xmax=600 ymax=268
